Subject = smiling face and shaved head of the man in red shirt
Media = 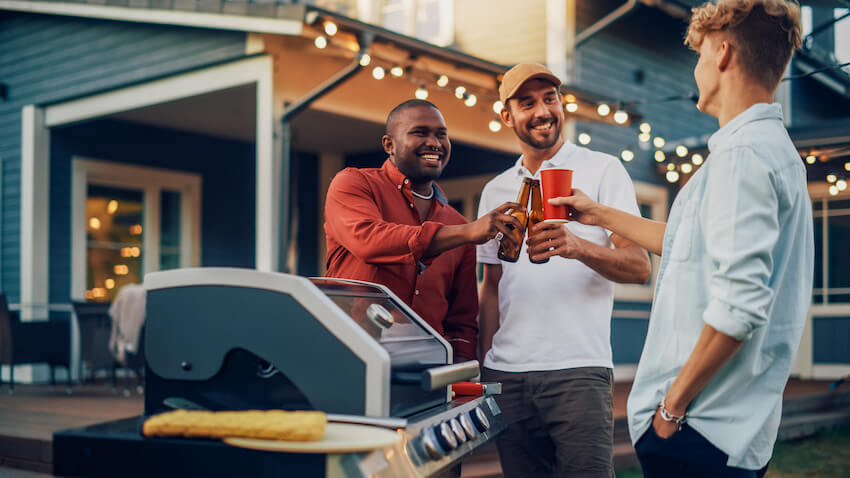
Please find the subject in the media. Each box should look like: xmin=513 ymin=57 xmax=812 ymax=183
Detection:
xmin=382 ymin=106 xmax=452 ymax=183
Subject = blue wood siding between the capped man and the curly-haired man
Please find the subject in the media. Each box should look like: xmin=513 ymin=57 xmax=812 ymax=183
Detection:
xmin=574 ymin=0 xmax=717 ymax=186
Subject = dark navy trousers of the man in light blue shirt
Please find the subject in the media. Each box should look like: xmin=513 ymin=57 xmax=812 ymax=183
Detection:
xmin=635 ymin=423 xmax=767 ymax=478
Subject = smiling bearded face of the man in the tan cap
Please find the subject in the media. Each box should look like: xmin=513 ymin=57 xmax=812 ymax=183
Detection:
xmin=501 ymin=79 xmax=564 ymax=149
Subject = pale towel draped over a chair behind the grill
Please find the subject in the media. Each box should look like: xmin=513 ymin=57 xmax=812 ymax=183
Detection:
xmin=109 ymin=284 xmax=145 ymax=364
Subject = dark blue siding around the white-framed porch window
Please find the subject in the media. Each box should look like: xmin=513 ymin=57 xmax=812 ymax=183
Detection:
xmin=49 ymin=120 xmax=256 ymax=303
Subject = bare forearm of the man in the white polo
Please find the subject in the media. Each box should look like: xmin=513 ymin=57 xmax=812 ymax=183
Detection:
xmin=578 ymin=239 xmax=651 ymax=284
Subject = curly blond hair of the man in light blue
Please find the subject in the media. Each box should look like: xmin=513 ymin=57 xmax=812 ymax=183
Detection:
xmin=685 ymin=0 xmax=803 ymax=91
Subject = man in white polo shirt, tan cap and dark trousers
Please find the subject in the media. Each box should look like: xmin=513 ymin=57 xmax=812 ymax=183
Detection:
xmin=478 ymin=63 xmax=650 ymax=478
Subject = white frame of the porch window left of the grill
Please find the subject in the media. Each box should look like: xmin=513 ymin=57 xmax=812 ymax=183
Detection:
xmin=71 ymin=161 xmax=201 ymax=301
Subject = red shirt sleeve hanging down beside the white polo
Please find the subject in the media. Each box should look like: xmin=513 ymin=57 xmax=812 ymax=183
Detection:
xmin=443 ymin=245 xmax=478 ymax=362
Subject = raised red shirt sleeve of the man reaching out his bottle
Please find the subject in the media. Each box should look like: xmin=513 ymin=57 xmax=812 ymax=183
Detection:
xmin=325 ymin=168 xmax=443 ymax=264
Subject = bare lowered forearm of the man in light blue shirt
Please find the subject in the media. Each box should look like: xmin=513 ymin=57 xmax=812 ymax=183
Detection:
xmin=664 ymin=325 xmax=744 ymax=415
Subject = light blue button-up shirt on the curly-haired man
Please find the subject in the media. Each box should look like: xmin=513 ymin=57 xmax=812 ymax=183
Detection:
xmin=628 ymin=103 xmax=814 ymax=470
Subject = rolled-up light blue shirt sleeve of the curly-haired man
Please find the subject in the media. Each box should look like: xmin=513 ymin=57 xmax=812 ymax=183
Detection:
xmin=699 ymin=147 xmax=779 ymax=340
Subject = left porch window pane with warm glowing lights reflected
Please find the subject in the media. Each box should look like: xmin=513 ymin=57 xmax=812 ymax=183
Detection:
xmin=86 ymin=185 xmax=144 ymax=302
